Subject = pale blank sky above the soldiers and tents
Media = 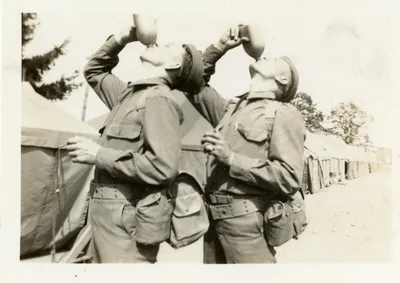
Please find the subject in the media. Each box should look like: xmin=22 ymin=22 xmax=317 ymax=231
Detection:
xmin=22 ymin=0 xmax=400 ymax=149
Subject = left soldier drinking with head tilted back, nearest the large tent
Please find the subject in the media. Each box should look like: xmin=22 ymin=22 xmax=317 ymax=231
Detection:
xmin=67 ymin=23 xmax=203 ymax=263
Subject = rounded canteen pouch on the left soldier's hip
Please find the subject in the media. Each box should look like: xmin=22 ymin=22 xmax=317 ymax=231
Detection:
xmin=136 ymin=190 xmax=174 ymax=245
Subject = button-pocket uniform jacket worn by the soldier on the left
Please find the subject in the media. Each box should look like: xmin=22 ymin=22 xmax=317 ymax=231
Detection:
xmin=84 ymin=36 xmax=183 ymax=186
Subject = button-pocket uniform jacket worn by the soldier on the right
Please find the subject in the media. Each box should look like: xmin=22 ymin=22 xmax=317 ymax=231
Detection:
xmin=191 ymin=46 xmax=305 ymax=199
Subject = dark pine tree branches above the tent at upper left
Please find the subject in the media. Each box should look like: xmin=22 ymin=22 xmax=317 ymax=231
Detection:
xmin=21 ymin=13 xmax=82 ymax=100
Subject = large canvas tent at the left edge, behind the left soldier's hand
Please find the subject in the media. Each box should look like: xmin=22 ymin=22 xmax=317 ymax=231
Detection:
xmin=20 ymin=83 xmax=98 ymax=257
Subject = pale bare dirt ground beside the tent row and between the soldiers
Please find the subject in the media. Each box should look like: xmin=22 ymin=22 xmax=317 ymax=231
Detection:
xmin=159 ymin=169 xmax=395 ymax=263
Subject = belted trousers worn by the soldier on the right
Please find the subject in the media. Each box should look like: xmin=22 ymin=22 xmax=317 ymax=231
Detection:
xmin=203 ymin=194 xmax=276 ymax=264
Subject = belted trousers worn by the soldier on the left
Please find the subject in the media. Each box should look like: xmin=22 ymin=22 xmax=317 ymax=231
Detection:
xmin=88 ymin=182 xmax=159 ymax=263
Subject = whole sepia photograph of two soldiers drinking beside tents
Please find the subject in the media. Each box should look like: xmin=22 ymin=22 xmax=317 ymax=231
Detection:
xmin=0 ymin=0 xmax=399 ymax=282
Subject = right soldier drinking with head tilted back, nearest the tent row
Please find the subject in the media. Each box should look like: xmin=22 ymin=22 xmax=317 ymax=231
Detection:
xmin=188 ymin=27 xmax=305 ymax=263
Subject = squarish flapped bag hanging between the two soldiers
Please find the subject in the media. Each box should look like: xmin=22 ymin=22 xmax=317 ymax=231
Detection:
xmin=170 ymin=193 xmax=210 ymax=248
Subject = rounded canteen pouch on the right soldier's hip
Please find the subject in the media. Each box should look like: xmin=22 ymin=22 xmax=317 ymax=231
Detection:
xmin=264 ymin=201 xmax=294 ymax=247
